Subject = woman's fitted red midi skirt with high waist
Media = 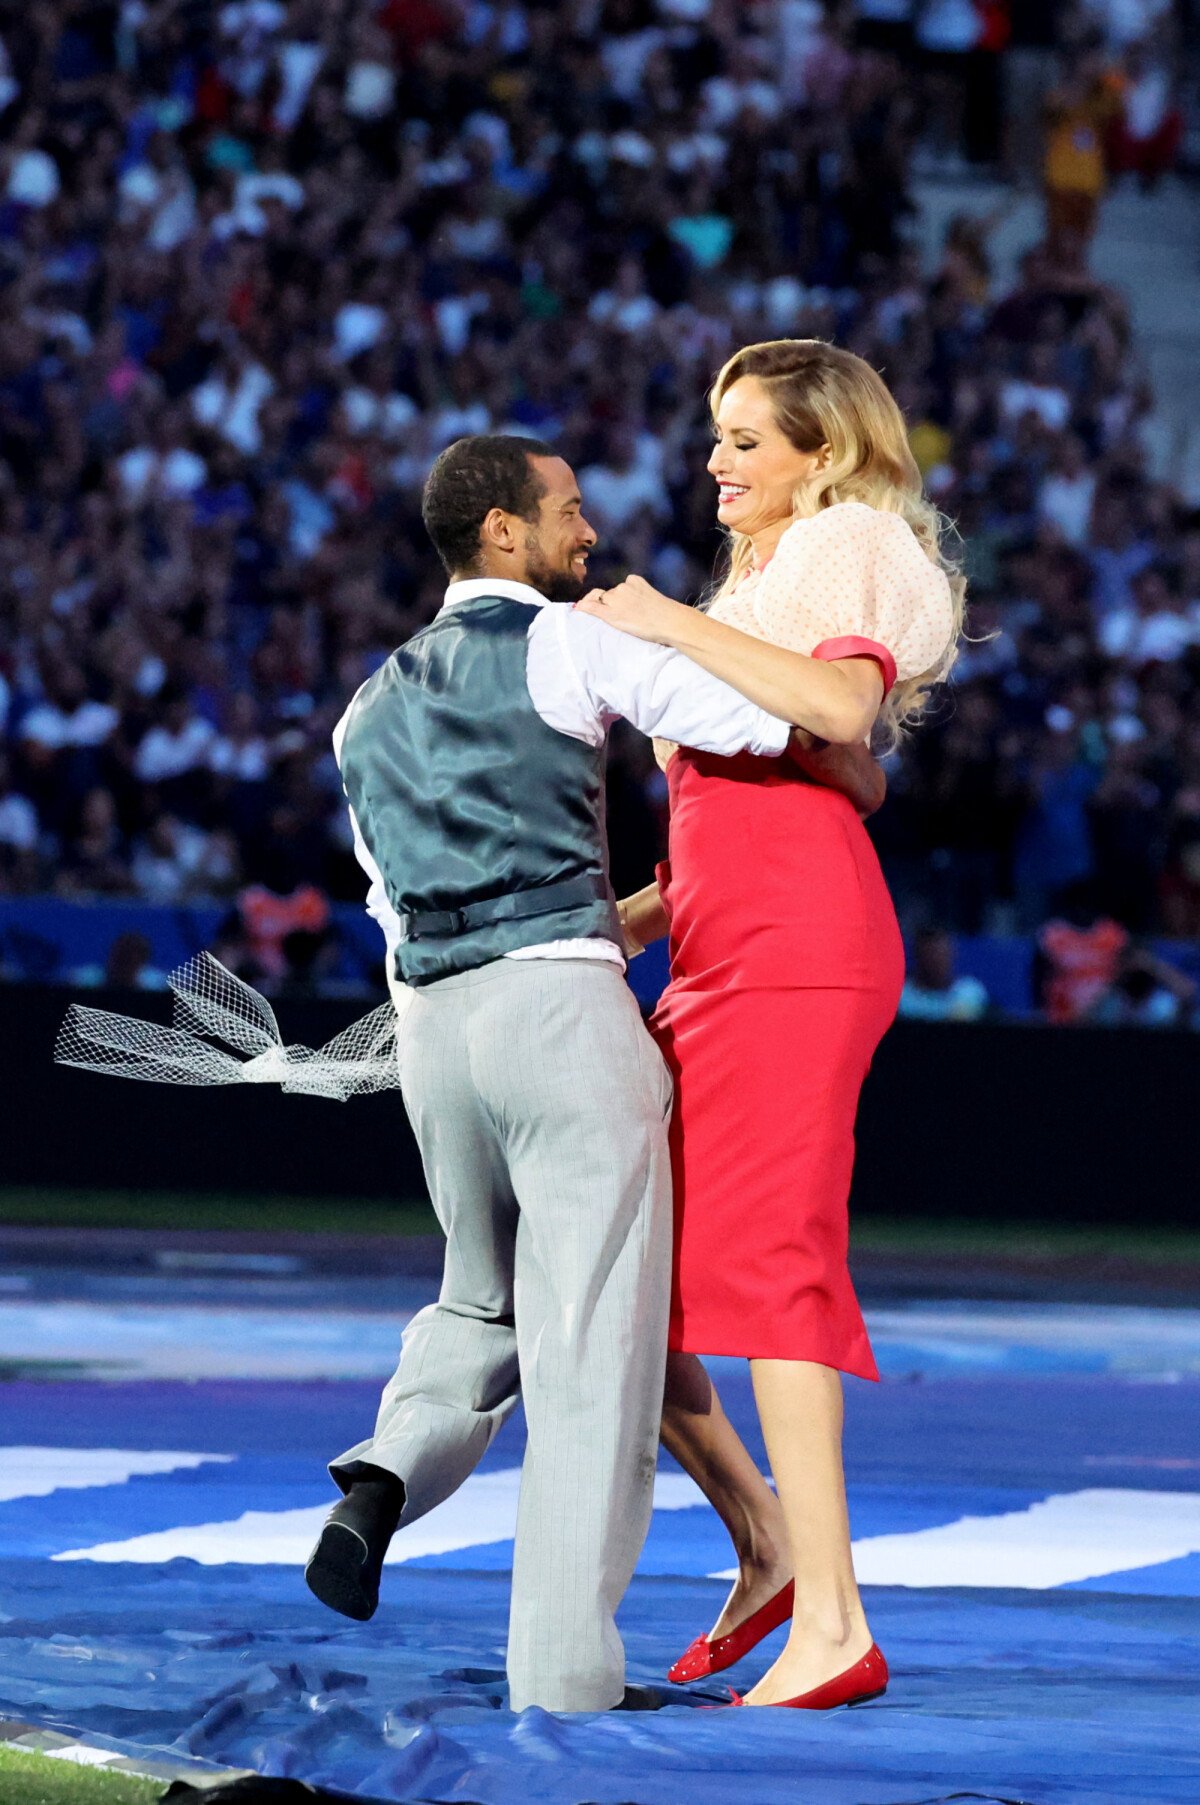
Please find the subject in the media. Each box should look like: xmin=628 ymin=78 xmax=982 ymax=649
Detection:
xmin=651 ymin=751 xmax=904 ymax=1379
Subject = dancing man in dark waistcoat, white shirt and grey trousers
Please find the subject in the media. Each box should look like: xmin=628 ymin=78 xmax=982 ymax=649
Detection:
xmin=307 ymin=437 xmax=866 ymax=1711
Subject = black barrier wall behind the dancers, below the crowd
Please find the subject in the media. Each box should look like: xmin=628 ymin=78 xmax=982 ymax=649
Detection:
xmin=0 ymin=986 xmax=1200 ymax=1227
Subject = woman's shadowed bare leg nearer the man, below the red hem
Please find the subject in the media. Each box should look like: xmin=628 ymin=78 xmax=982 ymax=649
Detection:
xmin=662 ymin=1354 xmax=792 ymax=1635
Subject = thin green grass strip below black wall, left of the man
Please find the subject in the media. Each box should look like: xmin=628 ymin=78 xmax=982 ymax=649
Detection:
xmin=0 ymin=1186 xmax=437 ymax=1235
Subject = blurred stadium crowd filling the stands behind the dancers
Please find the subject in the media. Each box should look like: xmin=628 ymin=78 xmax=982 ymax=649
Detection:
xmin=0 ymin=0 xmax=1200 ymax=1018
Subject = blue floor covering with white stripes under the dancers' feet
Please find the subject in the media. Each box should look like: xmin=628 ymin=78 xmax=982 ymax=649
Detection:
xmin=0 ymin=1277 xmax=1200 ymax=1805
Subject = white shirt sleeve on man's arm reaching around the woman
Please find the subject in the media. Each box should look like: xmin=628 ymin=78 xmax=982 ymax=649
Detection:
xmin=527 ymin=603 xmax=792 ymax=758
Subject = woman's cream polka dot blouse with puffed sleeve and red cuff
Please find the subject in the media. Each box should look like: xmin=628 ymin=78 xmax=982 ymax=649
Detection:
xmin=711 ymin=502 xmax=955 ymax=690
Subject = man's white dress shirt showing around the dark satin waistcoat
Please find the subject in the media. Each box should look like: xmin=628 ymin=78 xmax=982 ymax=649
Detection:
xmin=334 ymin=578 xmax=792 ymax=1009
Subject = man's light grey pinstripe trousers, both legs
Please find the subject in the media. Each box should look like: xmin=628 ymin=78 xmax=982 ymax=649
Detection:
xmin=330 ymin=958 xmax=671 ymax=1711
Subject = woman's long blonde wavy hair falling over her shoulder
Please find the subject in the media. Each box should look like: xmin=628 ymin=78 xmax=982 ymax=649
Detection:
xmin=707 ymin=339 xmax=967 ymax=749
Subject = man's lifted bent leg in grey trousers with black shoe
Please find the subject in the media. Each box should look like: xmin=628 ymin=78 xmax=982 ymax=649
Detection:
xmin=307 ymin=978 xmax=518 ymax=1617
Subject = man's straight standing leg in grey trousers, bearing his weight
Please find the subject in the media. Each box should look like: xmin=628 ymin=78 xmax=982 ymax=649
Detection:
xmin=473 ymin=960 xmax=671 ymax=1711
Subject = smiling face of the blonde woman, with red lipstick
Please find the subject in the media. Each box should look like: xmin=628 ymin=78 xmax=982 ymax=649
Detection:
xmin=707 ymin=375 xmax=828 ymax=534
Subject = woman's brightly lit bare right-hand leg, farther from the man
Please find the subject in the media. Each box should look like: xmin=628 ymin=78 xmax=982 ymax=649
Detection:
xmin=745 ymin=1359 xmax=872 ymax=1704
